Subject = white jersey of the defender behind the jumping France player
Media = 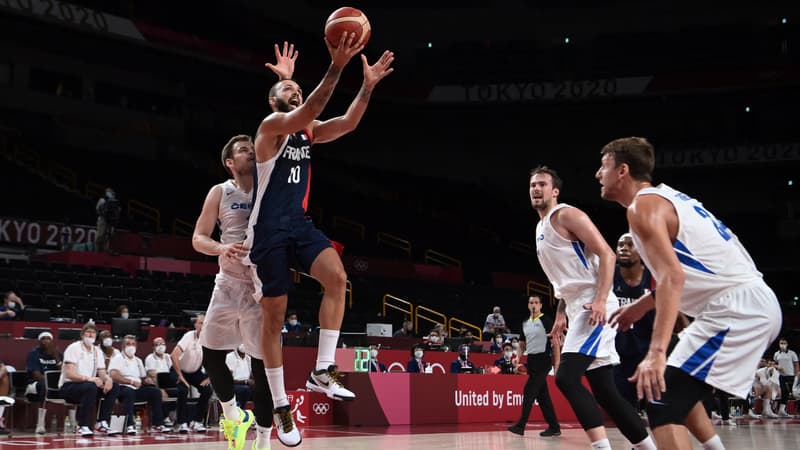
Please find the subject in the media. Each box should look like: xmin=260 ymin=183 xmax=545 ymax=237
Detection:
xmin=217 ymin=180 xmax=253 ymax=274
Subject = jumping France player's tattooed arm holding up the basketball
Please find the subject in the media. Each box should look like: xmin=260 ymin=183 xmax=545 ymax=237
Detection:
xmin=256 ymin=33 xmax=364 ymax=139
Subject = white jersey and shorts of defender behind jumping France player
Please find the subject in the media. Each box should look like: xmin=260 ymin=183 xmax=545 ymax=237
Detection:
xmin=200 ymin=180 xmax=262 ymax=359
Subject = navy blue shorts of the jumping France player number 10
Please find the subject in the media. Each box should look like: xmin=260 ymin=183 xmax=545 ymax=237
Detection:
xmin=249 ymin=216 xmax=332 ymax=297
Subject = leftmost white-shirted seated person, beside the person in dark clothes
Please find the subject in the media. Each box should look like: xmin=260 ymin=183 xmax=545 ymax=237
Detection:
xmin=58 ymin=323 xmax=119 ymax=436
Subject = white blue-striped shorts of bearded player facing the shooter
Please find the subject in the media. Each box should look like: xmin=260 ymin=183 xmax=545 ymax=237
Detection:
xmin=561 ymin=293 xmax=619 ymax=370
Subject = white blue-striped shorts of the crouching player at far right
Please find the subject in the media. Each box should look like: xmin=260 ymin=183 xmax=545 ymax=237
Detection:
xmin=667 ymin=280 xmax=782 ymax=398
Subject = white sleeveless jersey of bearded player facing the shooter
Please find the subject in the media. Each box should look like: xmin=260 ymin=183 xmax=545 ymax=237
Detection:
xmin=536 ymin=203 xmax=600 ymax=302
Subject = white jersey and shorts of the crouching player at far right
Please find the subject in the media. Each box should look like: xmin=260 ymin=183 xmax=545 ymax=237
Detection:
xmin=632 ymin=184 xmax=781 ymax=398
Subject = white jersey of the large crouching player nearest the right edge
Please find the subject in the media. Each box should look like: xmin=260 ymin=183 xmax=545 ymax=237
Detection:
xmin=631 ymin=184 xmax=761 ymax=316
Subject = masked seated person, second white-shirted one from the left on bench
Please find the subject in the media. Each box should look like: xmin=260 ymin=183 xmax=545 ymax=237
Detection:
xmin=108 ymin=334 xmax=172 ymax=434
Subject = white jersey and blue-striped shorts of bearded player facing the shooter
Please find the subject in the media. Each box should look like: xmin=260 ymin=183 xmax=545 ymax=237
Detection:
xmin=536 ymin=203 xmax=619 ymax=370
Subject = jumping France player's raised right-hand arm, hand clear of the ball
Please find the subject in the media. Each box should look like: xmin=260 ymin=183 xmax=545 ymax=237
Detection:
xmin=313 ymin=50 xmax=394 ymax=143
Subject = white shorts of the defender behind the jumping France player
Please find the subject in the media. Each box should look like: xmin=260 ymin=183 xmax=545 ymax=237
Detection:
xmin=200 ymin=273 xmax=263 ymax=359
